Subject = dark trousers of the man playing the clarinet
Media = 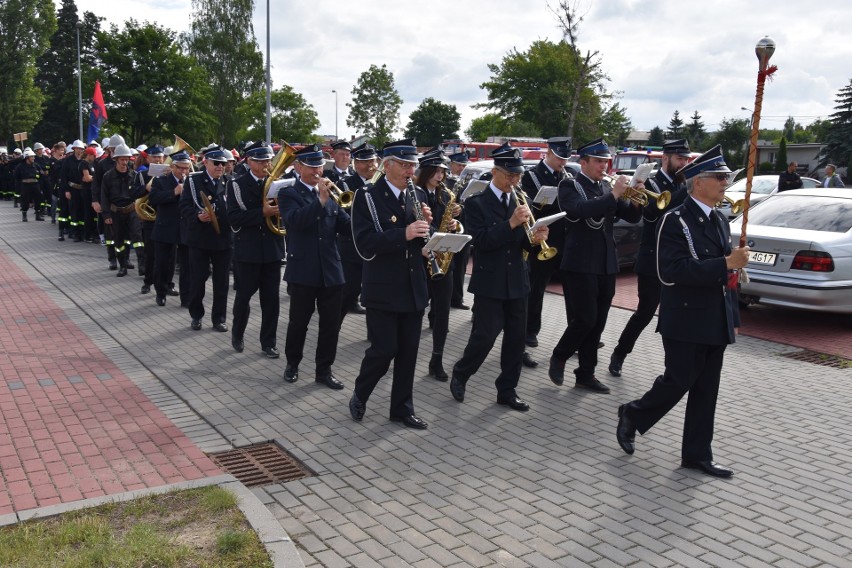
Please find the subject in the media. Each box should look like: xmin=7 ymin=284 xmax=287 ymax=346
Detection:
xmin=355 ymin=307 xmax=423 ymax=418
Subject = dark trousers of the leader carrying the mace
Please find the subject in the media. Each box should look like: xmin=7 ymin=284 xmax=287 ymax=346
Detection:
xmin=625 ymin=337 xmax=727 ymax=461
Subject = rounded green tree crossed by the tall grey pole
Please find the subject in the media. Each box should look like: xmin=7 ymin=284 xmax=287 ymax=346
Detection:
xmin=238 ymin=85 xmax=320 ymax=142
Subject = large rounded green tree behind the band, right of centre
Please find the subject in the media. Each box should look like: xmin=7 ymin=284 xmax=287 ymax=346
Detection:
xmin=474 ymin=40 xmax=609 ymax=140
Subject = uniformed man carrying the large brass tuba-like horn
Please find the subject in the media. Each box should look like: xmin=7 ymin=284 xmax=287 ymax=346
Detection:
xmin=228 ymin=141 xmax=284 ymax=352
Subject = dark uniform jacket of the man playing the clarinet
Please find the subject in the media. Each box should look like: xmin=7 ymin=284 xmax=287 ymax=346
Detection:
xmin=352 ymin=178 xmax=429 ymax=312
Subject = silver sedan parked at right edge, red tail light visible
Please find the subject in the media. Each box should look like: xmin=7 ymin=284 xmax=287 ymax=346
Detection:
xmin=731 ymin=188 xmax=852 ymax=314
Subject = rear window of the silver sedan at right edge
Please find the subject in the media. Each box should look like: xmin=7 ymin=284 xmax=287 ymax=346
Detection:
xmin=749 ymin=193 xmax=852 ymax=233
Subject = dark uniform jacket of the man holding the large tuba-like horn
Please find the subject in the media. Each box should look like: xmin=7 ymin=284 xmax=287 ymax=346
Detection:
xmin=228 ymin=172 xmax=284 ymax=262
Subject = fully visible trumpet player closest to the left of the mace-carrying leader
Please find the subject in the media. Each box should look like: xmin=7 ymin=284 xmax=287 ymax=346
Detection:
xmin=548 ymin=138 xmax=642 ymax=393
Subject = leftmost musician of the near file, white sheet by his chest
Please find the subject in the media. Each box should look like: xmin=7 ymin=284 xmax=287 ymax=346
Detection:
xmin=148 ymin=152 xmax=192 ymax=306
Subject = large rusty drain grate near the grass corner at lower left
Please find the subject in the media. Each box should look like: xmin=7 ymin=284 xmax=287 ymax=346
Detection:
xmin=208 ymin=442 xmax=316 ymax=487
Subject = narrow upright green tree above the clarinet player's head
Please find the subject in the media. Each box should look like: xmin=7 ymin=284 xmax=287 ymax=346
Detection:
xmin=346 ymin=64 xmax=402 ymax=148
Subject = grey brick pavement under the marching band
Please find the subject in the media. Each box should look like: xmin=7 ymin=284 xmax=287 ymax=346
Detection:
xmin=0 ymin=202 xmax=852 ymax=567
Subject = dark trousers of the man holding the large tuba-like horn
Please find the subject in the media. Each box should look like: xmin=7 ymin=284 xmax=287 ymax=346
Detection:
xmin=231 ymin=261 xmax=281 ymax=349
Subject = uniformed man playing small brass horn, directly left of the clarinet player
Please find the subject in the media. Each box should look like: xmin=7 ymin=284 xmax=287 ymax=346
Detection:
xmin=278 ymin=145 xmax=352 ymax=390
